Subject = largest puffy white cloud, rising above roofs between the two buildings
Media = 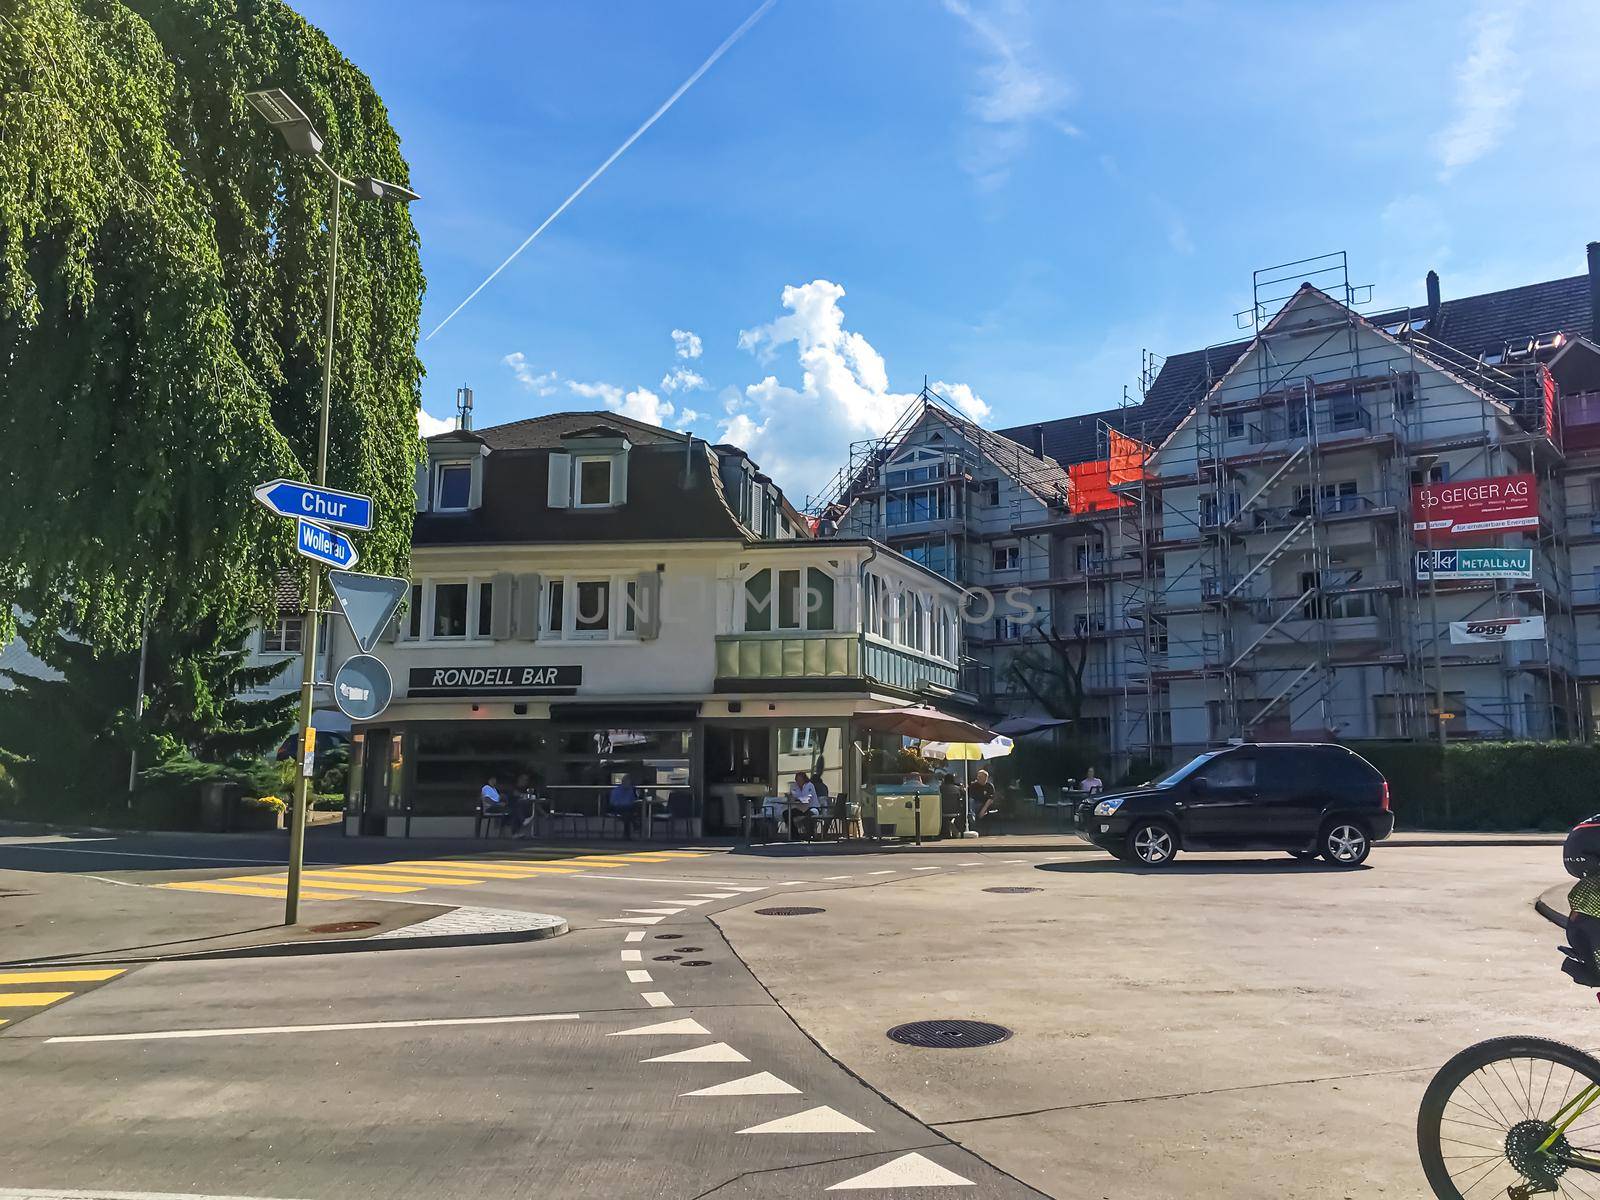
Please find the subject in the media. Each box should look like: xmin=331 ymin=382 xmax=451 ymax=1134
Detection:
xmin=720 ymin=278 xmax=989 ymax=502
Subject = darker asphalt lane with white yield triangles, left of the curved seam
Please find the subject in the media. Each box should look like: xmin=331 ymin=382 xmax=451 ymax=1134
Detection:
xmin=0 ymin=838 xmax=1056 ymax=1200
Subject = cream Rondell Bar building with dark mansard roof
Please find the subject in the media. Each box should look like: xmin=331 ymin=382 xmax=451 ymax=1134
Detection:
xmin=334 ymin=413 xmax=960 ymax=835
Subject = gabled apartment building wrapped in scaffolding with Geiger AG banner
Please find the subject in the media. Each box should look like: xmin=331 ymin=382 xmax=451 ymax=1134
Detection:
xmin=816 ymin=243 xmax=1600 ymax=758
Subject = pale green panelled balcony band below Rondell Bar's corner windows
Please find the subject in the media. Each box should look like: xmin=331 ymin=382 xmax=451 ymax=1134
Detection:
xmin=715 ymin=630 xmax=960 ymax=693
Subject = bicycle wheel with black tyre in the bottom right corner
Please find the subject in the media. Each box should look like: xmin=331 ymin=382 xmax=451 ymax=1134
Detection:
xmin=1416 ymin=1037 xmax=1600 ymax=1200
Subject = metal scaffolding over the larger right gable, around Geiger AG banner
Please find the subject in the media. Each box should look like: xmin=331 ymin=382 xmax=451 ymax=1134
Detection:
xmin=1117 ymin=253 xmax=1574 ymax=758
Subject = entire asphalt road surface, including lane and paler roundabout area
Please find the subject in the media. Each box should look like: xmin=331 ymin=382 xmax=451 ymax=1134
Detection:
xmin=0 ymin=837 xmax=1574 ymax=1200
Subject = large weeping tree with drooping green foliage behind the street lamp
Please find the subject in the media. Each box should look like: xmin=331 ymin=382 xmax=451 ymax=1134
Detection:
xmin=0 ymin=0 xmax=422 ymax=651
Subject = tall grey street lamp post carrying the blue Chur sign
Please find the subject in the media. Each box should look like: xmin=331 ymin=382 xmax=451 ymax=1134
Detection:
xmin=245 ymin=88 xmax=421 ymax=925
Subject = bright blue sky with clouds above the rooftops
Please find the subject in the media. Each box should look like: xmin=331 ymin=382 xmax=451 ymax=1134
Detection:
xmin=299 ymin=0 xmax=1600 ymax=501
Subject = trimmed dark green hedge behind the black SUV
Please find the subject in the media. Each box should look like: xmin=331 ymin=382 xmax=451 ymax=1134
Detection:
xmin=1350 ymin=742 xmax=1600 ymax=830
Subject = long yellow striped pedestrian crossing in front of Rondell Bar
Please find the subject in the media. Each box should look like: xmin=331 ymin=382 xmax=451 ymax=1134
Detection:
xmin=155 ymin=850 xmax=710 ymax=899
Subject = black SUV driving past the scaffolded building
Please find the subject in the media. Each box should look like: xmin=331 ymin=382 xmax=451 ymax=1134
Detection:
xmin=1074 ymin=742 xmax=1395 ymax=867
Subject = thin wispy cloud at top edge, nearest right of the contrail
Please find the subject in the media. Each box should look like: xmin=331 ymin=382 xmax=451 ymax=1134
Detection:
xmin=944 ymin=0 xmax=1078 ymax=190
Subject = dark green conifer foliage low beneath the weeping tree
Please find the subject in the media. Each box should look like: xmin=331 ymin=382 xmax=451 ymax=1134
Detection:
xmin=0 ymin=618 xmax=296 ymax=802
